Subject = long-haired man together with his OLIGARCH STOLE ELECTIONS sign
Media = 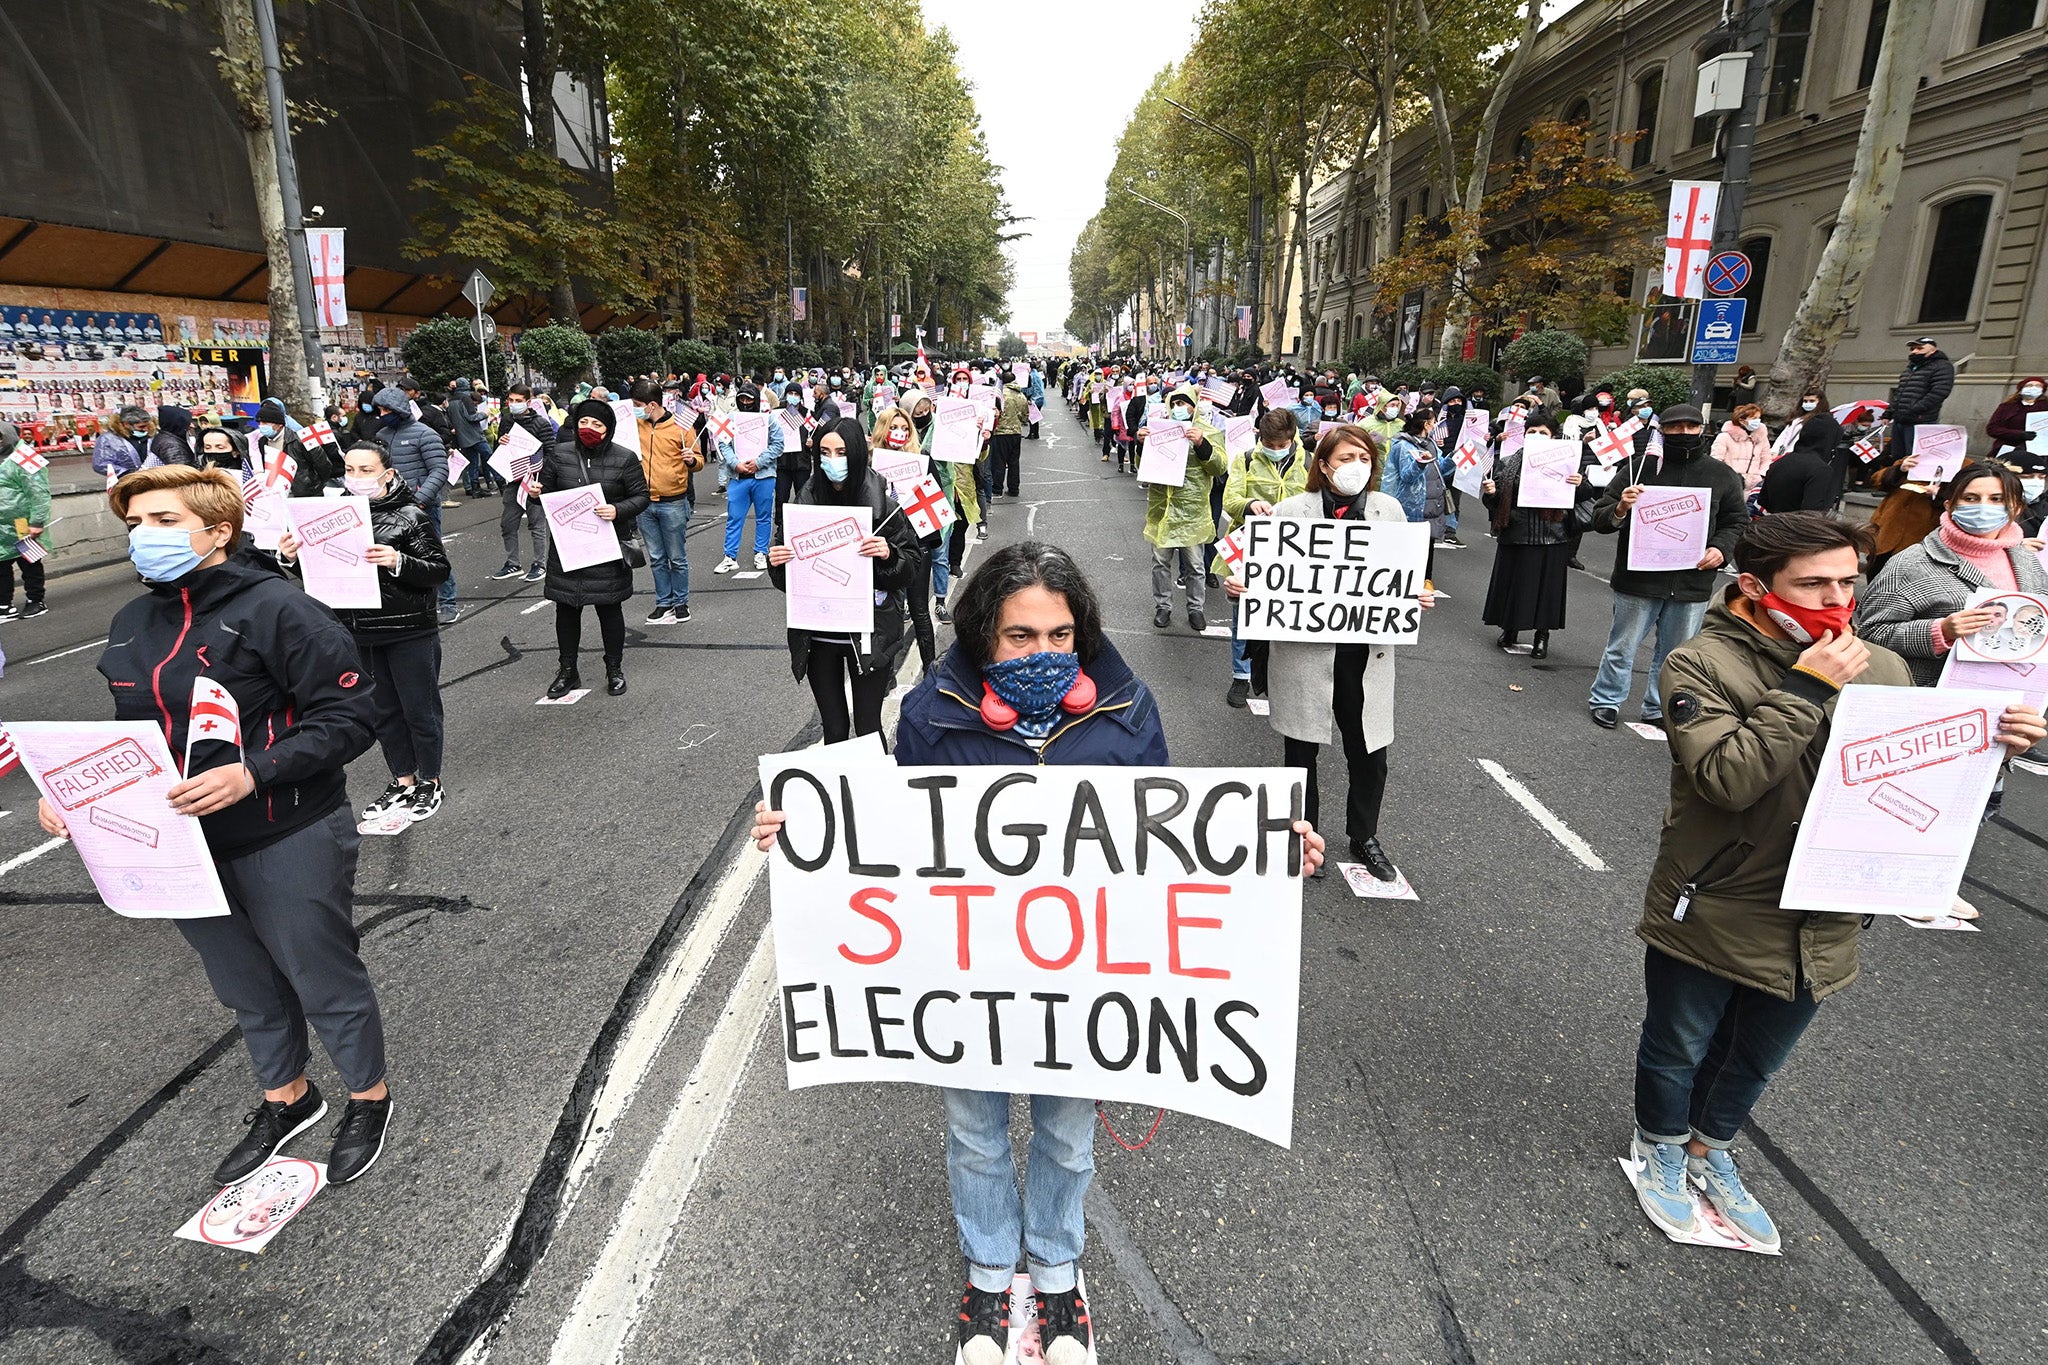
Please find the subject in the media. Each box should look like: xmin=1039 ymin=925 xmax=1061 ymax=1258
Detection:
xmin=754 ymin=542 xmax=1323 ymax=1365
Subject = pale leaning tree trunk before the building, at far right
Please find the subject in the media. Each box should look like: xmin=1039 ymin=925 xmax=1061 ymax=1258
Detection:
xmin=1763 ymin=0 xmax=1935 ymax=420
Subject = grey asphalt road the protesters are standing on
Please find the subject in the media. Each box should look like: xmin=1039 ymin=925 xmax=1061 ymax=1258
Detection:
xmin=0 ymin=405 xmax=2048 ymax=1365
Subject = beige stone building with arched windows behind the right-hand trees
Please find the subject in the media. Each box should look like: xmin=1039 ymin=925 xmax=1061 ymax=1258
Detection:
xmin=1309 ymin=0 xmax=2048 ymax=431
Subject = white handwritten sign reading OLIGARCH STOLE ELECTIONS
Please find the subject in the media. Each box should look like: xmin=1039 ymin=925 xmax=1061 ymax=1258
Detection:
xmin=760 ymin=749 xmax=1303 ymax=1146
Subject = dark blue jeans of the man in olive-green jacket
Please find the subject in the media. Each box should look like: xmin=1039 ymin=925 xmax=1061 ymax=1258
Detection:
xmin=1636 ymin=948 xmax=1821 ymax=1148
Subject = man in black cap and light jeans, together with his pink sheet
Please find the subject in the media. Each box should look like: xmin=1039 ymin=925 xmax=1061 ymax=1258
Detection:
xmin=1585 ymin=403 xmax=1749 ymax=731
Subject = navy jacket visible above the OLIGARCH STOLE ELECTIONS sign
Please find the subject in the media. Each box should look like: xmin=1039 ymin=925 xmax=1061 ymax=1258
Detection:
xmin=895 ymin=641 xmax=1169 ymax=767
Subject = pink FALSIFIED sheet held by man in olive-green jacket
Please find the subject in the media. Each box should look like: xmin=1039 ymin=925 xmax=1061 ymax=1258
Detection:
xmin=1780 ymin=684 xmax=2019 ymax=915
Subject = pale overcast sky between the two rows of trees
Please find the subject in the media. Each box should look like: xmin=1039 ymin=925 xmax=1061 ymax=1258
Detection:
xmin=924 ymin=0 xmax=1200 ymax=332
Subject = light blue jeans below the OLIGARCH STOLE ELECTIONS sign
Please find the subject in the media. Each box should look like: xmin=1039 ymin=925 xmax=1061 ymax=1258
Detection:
xmin=940 ymin=1089 xmax=1096 ymax=1293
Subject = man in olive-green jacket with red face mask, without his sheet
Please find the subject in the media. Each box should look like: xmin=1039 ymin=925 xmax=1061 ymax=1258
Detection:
xmin=1632 ymin=512 xmax=2048 ymax=1250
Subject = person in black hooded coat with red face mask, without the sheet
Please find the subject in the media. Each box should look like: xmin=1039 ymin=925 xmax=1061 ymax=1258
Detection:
xmin=541 ymin=399 xmax=649 ymax=698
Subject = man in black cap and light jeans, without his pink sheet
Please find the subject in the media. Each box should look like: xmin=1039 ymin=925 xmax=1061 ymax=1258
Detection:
xmin=1585 ymin=403 xmax=1749 ymax=731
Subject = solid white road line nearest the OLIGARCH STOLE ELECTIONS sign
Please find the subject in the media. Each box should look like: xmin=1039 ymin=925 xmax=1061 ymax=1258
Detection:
xmin=549 ymin=931 xmax=774 ymax=1365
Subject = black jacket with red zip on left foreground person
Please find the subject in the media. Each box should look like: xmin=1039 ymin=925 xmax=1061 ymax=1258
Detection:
xmin=98 ymin=555 xmax=375 ymax=857
